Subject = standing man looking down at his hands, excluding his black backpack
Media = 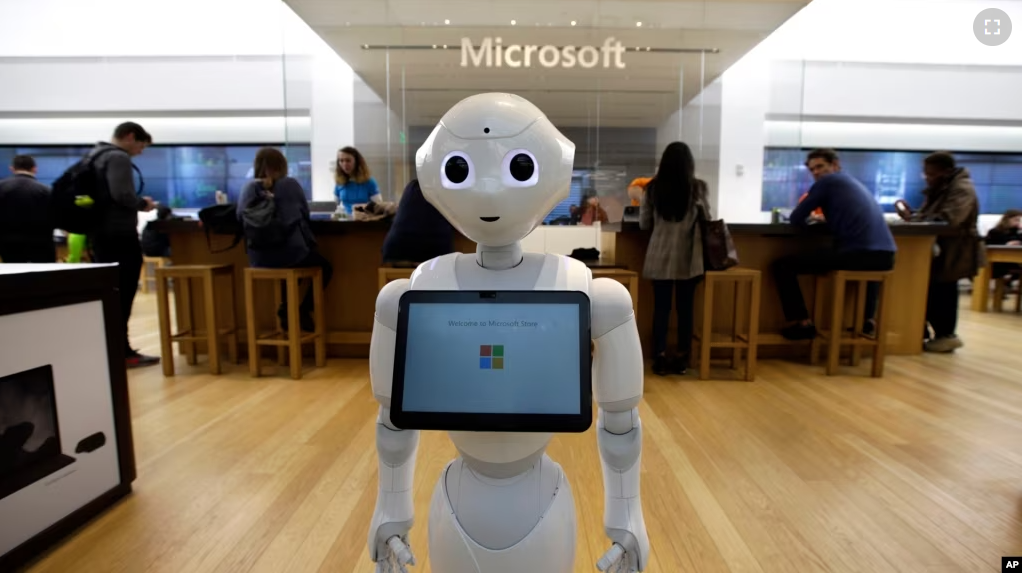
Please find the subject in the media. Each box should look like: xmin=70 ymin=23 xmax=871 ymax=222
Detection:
xmin=89 ymin=122 xmax=160 ymax=368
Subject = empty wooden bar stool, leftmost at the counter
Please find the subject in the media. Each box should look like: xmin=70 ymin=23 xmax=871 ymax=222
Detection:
xmin=157 ymin=264 xmax=238 ymax=377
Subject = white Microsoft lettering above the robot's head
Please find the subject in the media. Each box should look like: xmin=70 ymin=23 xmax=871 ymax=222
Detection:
xmin=461 ymin=37 xmax=625 ymax=70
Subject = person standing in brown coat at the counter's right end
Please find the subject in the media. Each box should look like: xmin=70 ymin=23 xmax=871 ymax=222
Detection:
xmin=899 ymin=151 xmax=987 ymax=353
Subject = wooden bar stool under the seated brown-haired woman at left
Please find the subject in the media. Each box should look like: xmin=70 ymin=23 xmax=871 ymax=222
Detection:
xmin=246 ymin=267 xmax=326 ymax=379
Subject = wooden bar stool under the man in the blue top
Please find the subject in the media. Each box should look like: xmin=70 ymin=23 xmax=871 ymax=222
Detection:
xmin=810 ymin=271 xmax=893 ymax=377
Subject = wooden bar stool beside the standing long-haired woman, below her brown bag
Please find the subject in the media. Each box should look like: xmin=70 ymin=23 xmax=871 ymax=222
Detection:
xmin=693 ymin=267 xmax=760 ymax=381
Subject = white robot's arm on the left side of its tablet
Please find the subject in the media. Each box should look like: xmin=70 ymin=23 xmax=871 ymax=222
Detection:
xmin=368 ymin=279 xmax=419 ymax=572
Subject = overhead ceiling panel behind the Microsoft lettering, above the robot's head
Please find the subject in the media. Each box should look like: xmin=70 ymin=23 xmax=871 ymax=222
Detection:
xmin=284 ymin=0 xmax=808 ymax=127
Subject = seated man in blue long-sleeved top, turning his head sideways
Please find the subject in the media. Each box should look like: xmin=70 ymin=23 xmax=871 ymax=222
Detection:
xmin=773 ymin=149 xmax=895 ymax=340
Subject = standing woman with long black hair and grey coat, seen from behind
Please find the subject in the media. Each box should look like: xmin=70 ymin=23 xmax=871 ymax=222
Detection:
xmin=639 ymin=141 xmax=710 ymax=377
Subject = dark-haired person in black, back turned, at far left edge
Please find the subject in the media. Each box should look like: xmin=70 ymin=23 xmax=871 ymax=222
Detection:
xmin=0 ymin=156 xmax=57 ymax=263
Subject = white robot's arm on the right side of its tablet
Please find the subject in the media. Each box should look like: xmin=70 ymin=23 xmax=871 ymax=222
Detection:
xmin=590 ymin=278 xmax=650 ymax=572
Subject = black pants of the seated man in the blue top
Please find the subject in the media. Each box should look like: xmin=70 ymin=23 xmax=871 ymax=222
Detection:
xmin=773 ymin=250 xmax=895 ymax=321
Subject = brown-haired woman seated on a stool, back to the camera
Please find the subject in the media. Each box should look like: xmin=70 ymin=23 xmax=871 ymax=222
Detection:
xmin=237 ymin=147 xmax=333 ymax=332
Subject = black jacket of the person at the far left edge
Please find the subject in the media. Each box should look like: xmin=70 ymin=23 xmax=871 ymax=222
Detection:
xmin=0 ymin=174 xmax=53 ymax=245
